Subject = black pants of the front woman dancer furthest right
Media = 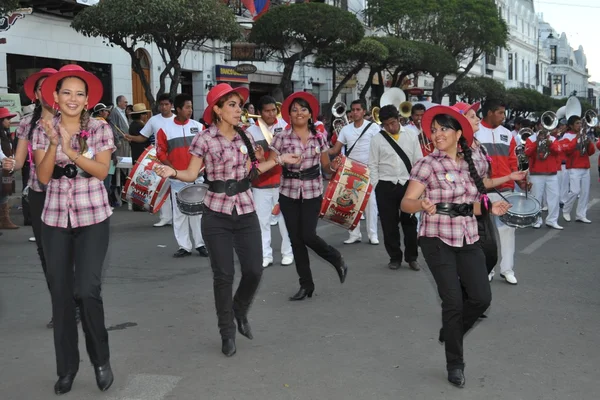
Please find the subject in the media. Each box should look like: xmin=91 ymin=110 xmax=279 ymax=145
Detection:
xmin=419 ymin=237 xmax=492 ymax=370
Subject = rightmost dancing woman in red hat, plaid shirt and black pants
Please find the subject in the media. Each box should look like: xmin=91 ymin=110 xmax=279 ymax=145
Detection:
xmin=401 ymin=106 xmax=510 ymax=387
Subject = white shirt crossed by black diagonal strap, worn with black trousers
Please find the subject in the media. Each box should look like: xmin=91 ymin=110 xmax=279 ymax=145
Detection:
xmin=369 ymin=127 xmax=423 ymax=188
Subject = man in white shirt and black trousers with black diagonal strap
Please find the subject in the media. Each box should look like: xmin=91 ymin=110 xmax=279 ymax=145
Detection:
xmin=369 ymin=105 xmax=423 ymax=271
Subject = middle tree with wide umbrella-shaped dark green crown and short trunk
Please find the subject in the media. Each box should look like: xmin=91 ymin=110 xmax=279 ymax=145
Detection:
xmin=249 ymin=3 xmax=365 ymax=97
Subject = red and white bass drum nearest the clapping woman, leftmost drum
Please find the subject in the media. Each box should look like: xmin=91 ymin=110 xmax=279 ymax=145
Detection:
xmin=121 ymin=146 xmax=171 ymax=214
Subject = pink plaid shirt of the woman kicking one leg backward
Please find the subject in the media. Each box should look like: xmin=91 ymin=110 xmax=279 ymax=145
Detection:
xmin=271 ymin=125 xmax=329 ymax=199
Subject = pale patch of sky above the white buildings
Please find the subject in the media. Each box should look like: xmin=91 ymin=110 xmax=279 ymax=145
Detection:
xmin=534 ymin=0 xmax=600 ymax=82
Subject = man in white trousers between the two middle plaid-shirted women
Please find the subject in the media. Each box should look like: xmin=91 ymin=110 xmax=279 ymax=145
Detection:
xmin=246 ymin=96 xmax=294 ymax=268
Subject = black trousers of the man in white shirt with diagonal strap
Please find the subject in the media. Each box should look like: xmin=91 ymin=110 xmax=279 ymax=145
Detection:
xmin=375 ymin=181 xmax=419 ymax=262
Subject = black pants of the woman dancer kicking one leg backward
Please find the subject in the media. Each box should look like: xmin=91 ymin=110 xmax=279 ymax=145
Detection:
xmin=279 ymin=194 xmax=342 ymax=290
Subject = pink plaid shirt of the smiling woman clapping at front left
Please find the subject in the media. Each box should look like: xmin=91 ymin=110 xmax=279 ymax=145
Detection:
xmin=32 ymin=117 xmax=116 ymax=228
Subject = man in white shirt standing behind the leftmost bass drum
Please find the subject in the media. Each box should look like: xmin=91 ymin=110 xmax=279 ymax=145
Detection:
xmin=136 ymin=93 xmax=175 ymax=228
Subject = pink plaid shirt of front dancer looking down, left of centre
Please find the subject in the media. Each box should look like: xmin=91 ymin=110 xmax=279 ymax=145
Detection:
xmin=189 ymin=125 xmax=255 ymax=215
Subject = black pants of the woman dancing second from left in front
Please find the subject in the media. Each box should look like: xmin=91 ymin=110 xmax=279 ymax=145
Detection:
xmin=202 ymin=207 xmax=263 ymax=338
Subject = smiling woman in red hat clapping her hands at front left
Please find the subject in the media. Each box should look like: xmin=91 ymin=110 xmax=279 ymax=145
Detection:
xmin=32 ymin=65 xmax=115 ymax=394
